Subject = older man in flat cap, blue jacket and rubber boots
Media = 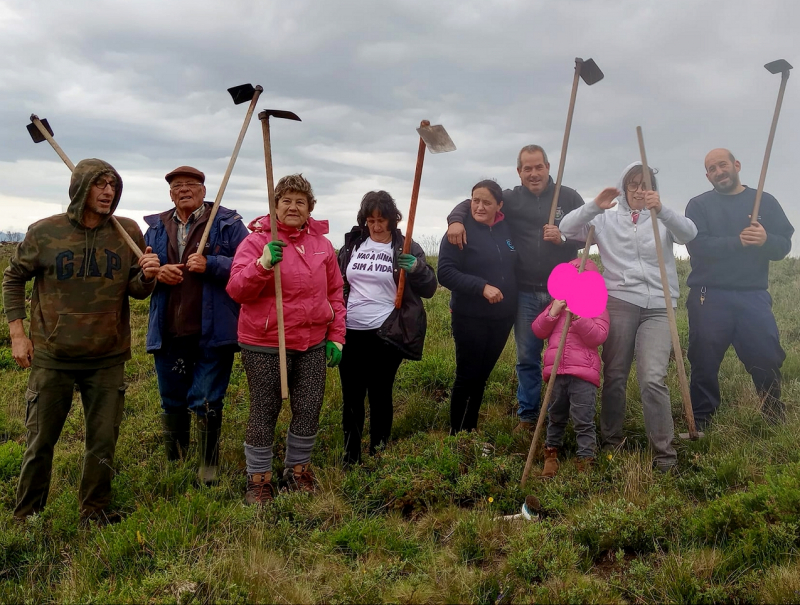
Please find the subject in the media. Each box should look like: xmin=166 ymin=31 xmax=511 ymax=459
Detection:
xmin=145 ymin=166 xmax=247 ymax=483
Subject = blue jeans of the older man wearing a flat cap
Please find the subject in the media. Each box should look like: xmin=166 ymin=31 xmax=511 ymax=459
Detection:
xmin=153 ymin=336 xmax=237 ymax=417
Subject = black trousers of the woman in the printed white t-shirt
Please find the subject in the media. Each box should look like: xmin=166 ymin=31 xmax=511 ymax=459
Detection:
xmin=339 ymin=329 xmax=403 ymax=464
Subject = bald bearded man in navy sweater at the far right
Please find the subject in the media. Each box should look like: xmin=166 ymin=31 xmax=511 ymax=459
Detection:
xmin=686 ymin=149 xmax=794 ymax=429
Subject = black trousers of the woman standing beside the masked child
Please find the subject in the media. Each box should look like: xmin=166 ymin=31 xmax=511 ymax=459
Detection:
xmin=450 ymin=313 xmax=512 ymax=435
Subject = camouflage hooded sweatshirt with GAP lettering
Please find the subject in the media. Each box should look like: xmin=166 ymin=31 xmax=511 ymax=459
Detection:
xmin=3 ymin=159 xmax=155 ymax=370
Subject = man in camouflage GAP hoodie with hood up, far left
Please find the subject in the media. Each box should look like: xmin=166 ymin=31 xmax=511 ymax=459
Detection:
xmin=3 ymin=159 xmax=159 ymax=523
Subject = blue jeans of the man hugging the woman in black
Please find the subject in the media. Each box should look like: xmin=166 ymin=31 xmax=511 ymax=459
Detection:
xmin=514 ymin=292 xmax=550 ymax=424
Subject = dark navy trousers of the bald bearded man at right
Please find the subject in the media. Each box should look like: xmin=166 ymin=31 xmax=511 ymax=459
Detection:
xmin=686 ymin=288 xmax=786 ymax=428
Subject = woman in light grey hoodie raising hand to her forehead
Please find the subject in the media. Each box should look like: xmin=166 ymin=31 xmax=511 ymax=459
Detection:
xmin=560 ymin=162 xmax=697 ymax=472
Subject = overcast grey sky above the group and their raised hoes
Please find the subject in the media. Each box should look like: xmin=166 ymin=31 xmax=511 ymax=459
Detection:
xmin=0 ymin=0 xmax=800 ymax=254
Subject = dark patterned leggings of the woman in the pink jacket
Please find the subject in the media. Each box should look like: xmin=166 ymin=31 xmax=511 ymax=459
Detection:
xmin=242 ymin=348 xmax=326 ymax=447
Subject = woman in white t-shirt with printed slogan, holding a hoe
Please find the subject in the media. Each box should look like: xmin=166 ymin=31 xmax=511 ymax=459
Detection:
xmin=339 ymin=191 xmax=437 ymax=466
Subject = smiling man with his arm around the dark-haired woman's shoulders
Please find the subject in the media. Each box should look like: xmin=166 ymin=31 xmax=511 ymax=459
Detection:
xmin=447 ymin=145 xmax=583 ymax=430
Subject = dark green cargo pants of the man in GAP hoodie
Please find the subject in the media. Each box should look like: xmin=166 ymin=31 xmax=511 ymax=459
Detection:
xmin=14 ymin=364 xmax=127 ymax=518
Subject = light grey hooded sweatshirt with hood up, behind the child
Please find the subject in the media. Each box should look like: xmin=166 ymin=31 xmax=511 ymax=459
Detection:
xmin=561 ymin=162 xmax=697 ymax=309
